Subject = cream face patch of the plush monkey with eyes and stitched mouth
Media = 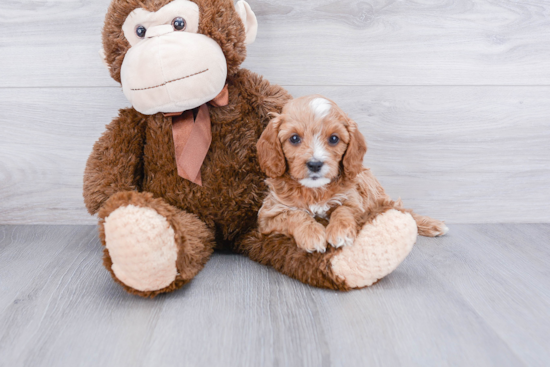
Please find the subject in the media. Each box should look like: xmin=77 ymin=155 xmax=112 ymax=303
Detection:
xmin=120 ymin=0 xmax=227 ymax=115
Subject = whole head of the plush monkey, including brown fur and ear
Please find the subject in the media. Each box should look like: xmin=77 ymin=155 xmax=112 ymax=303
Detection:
xmin=105 ymin=0 xmax=258 ymax=115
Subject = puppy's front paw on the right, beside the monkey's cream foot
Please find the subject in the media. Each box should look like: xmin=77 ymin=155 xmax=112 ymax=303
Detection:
xmin=326 ymin=205 xmax=357 ymax=247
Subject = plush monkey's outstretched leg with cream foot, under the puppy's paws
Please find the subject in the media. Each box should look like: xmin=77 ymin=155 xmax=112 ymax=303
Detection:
xmin=239 ymin=209 xmax=418 ymax=290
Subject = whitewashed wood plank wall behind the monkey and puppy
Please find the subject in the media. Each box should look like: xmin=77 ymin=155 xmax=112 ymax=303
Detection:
xmin=0 ymin=0 xmax=550 ymax=224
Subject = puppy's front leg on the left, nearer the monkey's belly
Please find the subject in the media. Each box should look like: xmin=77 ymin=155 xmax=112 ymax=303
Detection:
xmin=260 ymin=210 xmax=327 ymax=252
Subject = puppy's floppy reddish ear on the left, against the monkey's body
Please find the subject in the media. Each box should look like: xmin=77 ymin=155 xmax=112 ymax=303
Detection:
xmin=256 ymin=114 xmax=286 ymax=178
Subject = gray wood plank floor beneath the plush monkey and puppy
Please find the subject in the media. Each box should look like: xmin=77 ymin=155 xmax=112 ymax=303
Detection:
xmin=0 ymin=224 xmax=550 ymax=367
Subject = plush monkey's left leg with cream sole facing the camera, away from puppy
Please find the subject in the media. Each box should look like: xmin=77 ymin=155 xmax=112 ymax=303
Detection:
xmin=98 ymin=191 xmax=214 ymax=297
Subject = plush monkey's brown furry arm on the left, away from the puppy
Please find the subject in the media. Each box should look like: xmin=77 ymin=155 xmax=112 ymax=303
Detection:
xmin=83 ymin=108 xmax=146 ymax=214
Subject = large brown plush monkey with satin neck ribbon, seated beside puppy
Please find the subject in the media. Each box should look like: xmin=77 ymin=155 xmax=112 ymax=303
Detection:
xmin=84 ymin=0 xmax=446 ymax=297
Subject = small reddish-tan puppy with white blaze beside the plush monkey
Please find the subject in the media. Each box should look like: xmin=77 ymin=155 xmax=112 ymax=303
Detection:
xmin=257 ymin=95 xmax=448 ymax=252
